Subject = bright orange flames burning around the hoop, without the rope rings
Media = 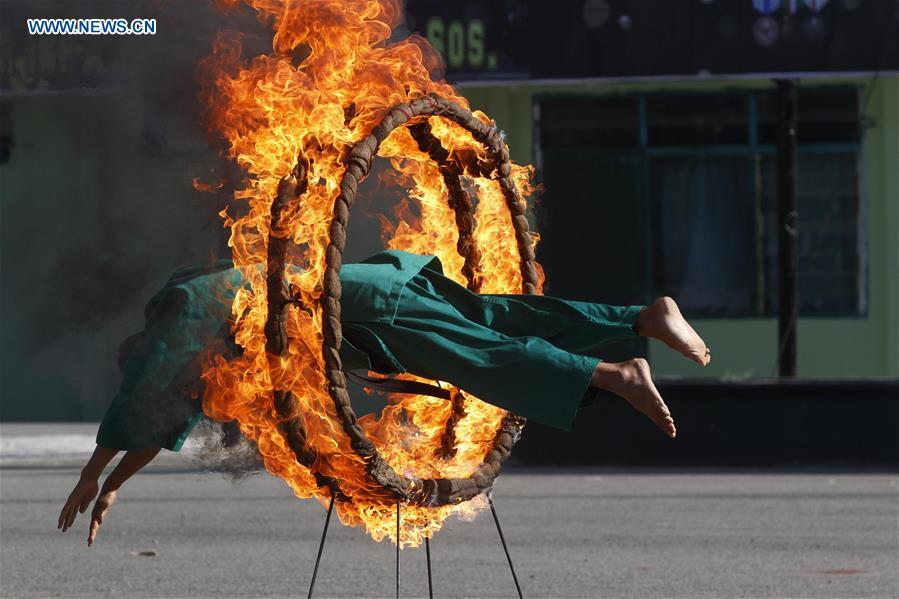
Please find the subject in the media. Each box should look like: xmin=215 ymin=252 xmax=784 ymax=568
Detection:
xmin=201 ymin=0 xmax=531 ymax=546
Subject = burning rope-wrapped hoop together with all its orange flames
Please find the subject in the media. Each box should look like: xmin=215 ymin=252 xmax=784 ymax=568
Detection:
xmin=203 ymin=0 xmax=542 ymax=546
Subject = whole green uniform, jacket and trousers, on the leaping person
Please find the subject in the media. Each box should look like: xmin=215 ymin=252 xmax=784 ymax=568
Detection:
xmin=97 ymin=250 xmax=640 ymax=451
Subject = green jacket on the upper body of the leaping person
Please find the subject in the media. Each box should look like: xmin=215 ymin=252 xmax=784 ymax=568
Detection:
xmin=97 ymin=250 xmax=441 ymax=451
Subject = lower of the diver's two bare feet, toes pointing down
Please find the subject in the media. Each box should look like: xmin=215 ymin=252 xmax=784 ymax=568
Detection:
xmin=591 ymin=358 xmax=677 ymax=438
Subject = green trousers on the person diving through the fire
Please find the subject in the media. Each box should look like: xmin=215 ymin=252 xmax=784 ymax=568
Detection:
xmin=344 ymin=268 xmax=641 ymax=430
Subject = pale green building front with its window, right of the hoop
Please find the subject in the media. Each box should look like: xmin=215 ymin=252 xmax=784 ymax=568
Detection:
xmin=463 ymin=75 xmax=899 ymax=379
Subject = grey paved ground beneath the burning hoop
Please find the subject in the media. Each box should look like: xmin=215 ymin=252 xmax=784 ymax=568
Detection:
xmin=0 ymin=424 xmax=899 ymax=598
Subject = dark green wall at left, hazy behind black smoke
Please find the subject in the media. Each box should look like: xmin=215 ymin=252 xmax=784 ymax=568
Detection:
xmin=0 ymin=93 xmax=232 ymax=421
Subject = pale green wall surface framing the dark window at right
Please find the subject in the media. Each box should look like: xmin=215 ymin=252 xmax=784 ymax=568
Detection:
xmin=462 ymin=75 xmax=899 ymax=379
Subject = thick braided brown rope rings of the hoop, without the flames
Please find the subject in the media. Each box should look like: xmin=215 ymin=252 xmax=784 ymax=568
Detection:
xmin=266 ymin=95 xmax=538 ymax=506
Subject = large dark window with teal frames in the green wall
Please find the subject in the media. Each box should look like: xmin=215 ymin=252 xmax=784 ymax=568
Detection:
xmin=537 ymin=87 xmax=867 ymax=317
